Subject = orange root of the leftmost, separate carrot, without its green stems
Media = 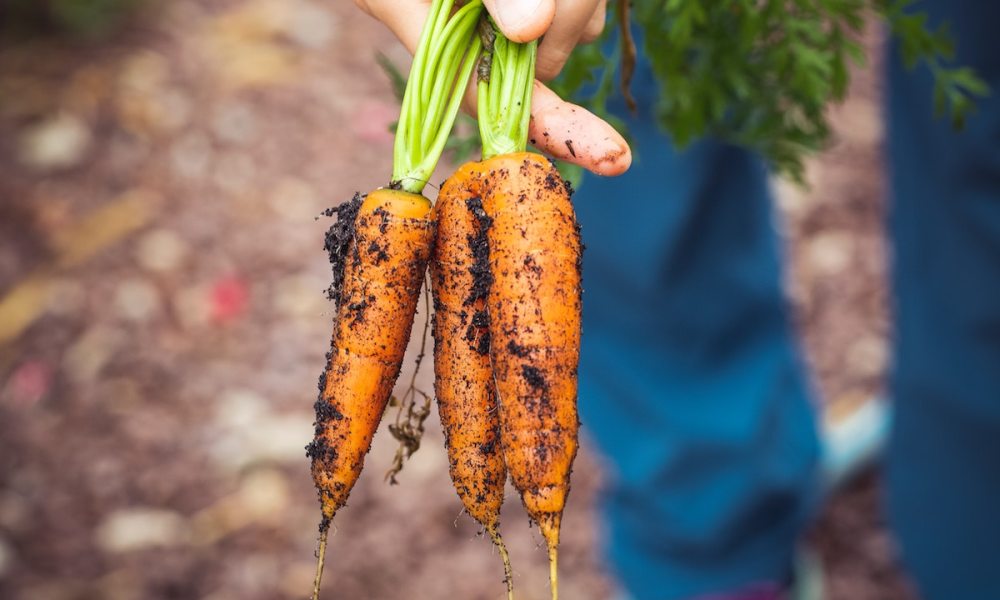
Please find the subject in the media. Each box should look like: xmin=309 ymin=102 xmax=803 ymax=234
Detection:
xmin=307 ymin=189 xmax=434 ymax=521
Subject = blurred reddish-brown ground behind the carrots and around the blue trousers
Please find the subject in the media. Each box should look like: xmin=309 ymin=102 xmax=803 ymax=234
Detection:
xmin=0 ymin=0 xmax=907 ymax=600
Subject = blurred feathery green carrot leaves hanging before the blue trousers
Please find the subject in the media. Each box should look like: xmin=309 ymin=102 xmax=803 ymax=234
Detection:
xmin=557 ymin=0 xmax=989 ymax=181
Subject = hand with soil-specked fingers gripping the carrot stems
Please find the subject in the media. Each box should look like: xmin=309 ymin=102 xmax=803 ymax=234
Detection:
xmin=355 ymin=0 xmax=632 ymax=175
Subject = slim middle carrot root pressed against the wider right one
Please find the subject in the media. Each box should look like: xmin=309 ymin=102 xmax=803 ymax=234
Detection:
xmin=430 ymin=163 xmax=513 ymax=598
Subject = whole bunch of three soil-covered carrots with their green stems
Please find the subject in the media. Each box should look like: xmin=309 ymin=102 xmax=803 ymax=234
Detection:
xmin=307 ymin=0 xmax=600 ymax=598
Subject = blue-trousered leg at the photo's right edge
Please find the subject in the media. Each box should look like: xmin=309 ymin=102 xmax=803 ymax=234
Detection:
xmin=888 ymin=0 xmax=1000 ymax=600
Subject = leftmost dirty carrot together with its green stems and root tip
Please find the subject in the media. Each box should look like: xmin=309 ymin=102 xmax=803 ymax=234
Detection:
xmin=306 ymin=0 xmax=482 ymax=599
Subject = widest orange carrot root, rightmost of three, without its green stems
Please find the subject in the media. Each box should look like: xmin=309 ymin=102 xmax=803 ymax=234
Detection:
xmin=482 ymin=152 xmax=582 ymax=598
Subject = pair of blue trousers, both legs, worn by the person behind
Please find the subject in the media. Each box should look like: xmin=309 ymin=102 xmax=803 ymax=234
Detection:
xmin=575 ymin=0 xmax=1000 ymax=600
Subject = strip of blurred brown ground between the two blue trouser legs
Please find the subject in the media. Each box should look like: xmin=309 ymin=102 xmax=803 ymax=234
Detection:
xmin=778 ymin=31 xmax=916 ymax=600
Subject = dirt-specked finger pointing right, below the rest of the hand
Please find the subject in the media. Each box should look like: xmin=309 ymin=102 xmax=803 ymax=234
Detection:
xmin=528 ymin=81 xmax=632 ymax=175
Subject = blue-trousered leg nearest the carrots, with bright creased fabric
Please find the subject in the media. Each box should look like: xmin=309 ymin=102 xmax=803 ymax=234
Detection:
xmin=574 ymin=58 xmax=817 ymax=600
